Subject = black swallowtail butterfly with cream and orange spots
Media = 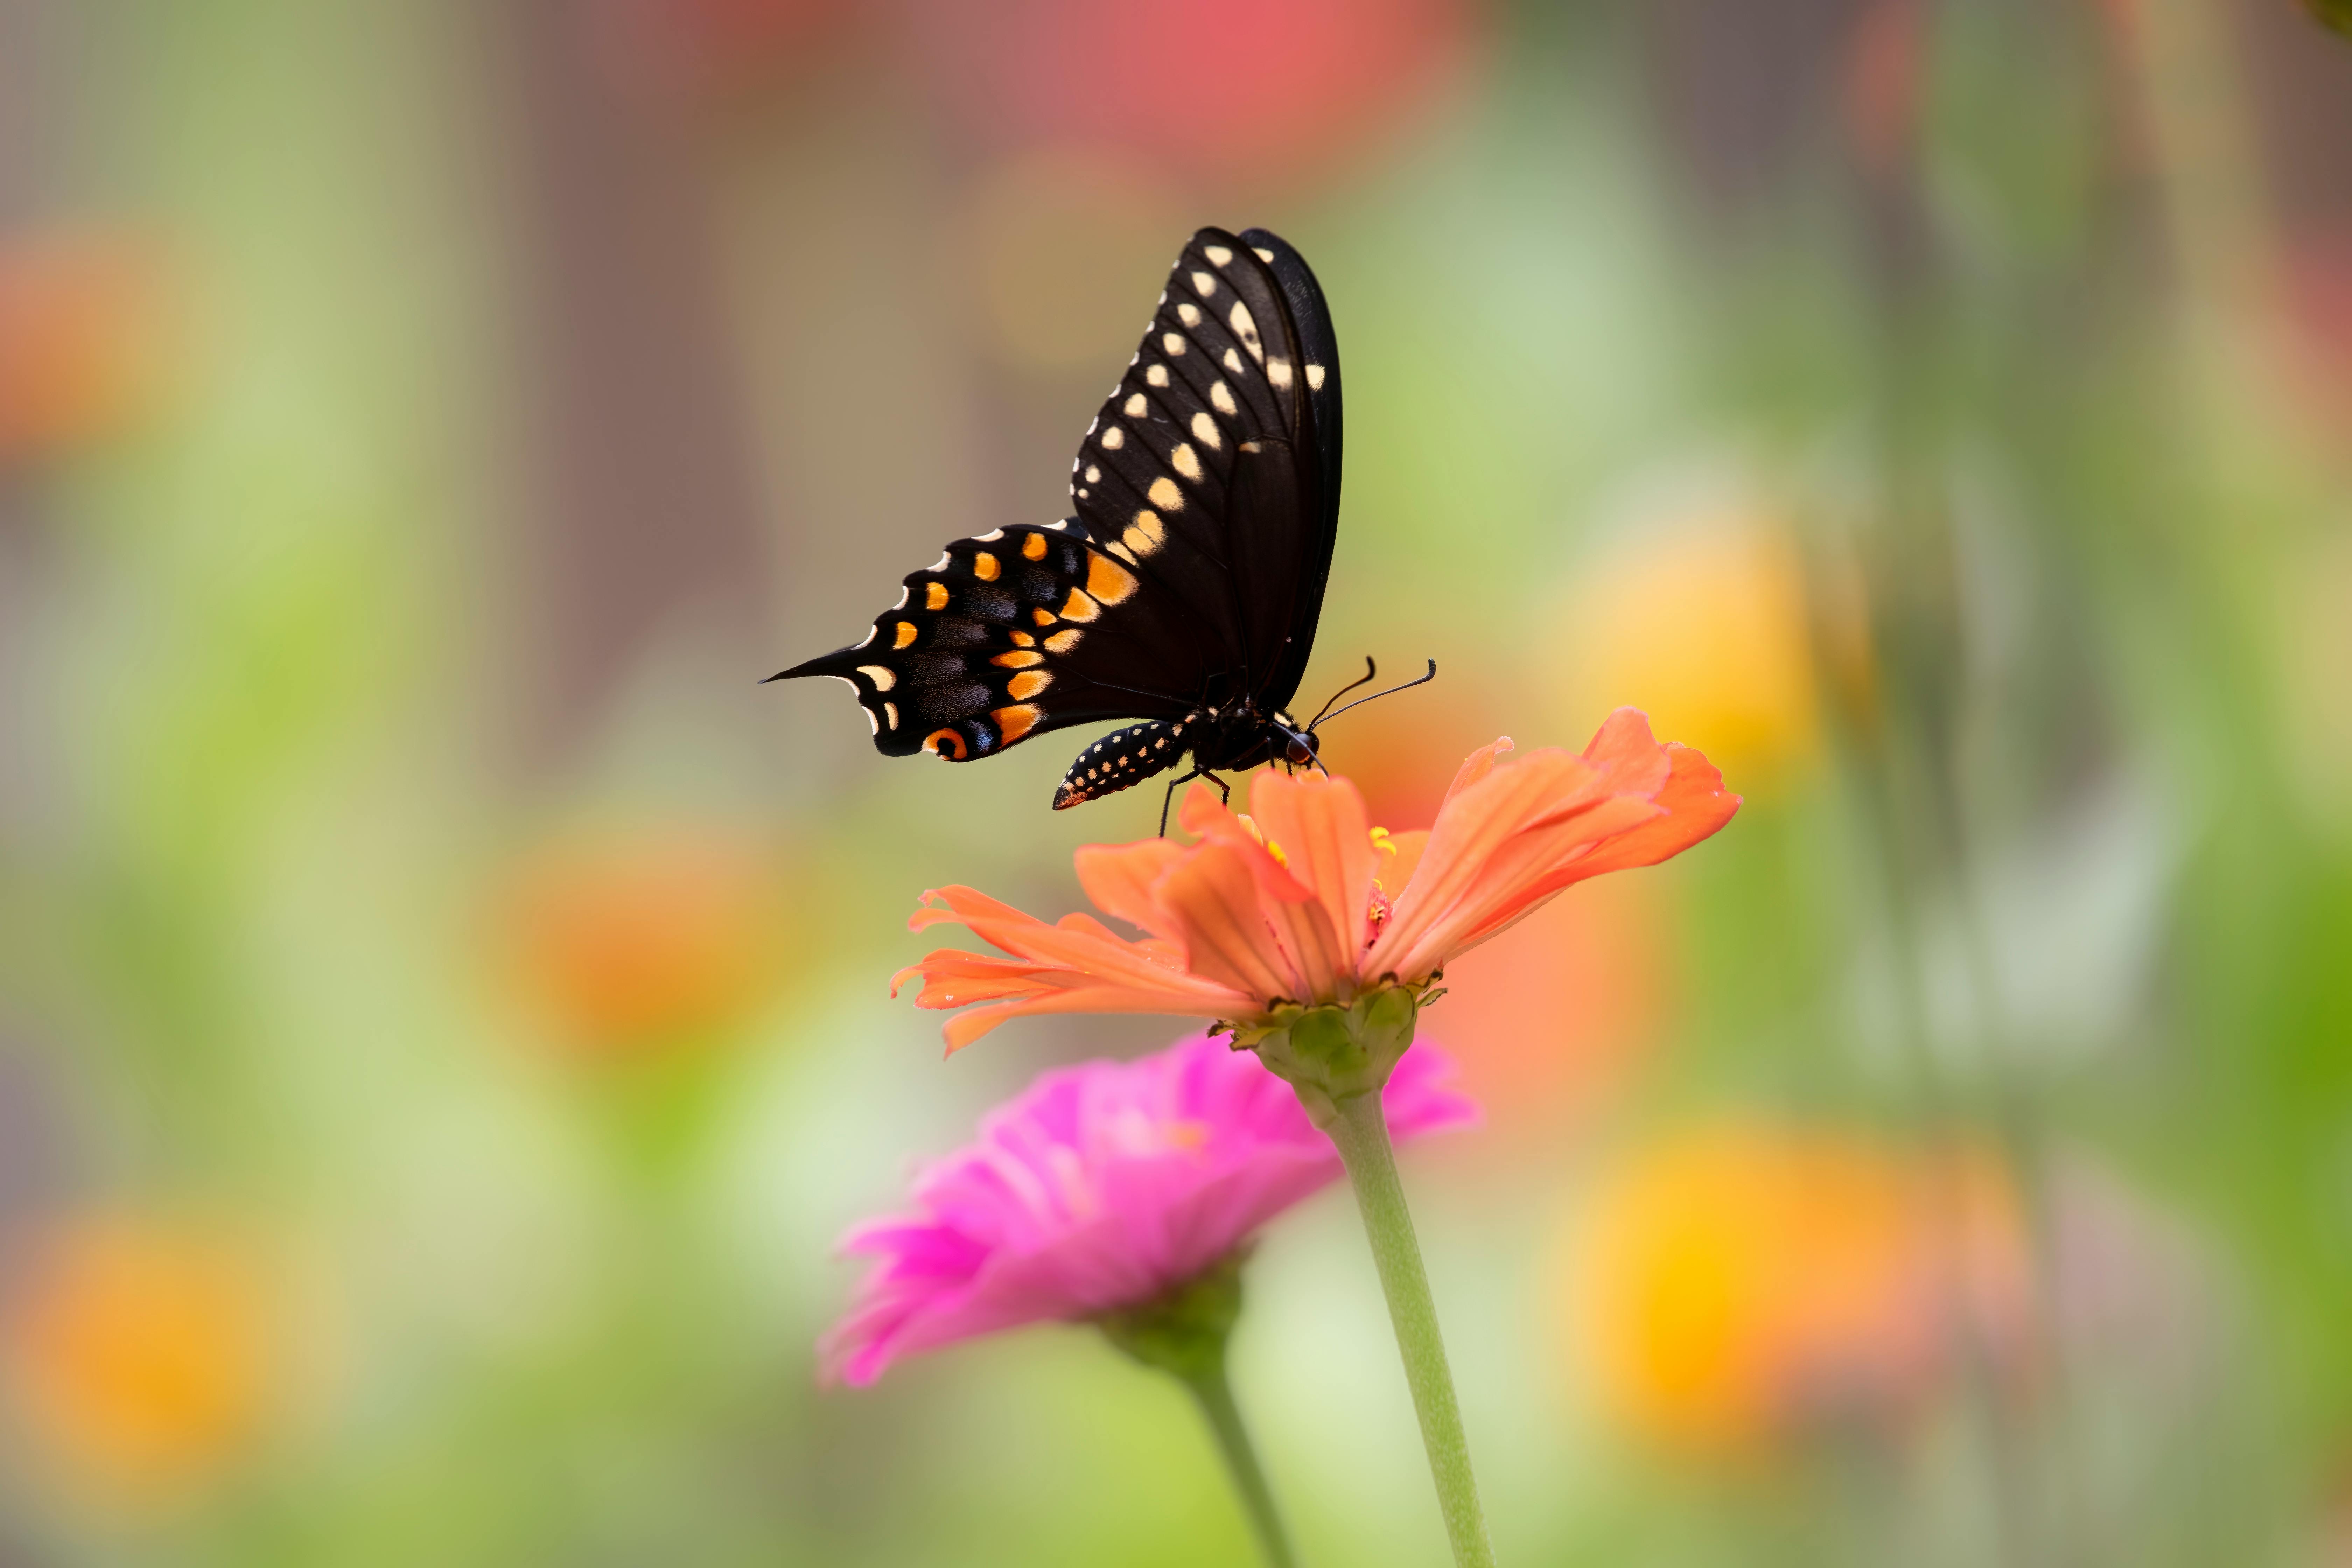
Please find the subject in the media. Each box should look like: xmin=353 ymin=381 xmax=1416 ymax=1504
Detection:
xmin=769 ymin=228 xmax=1437 ymax=830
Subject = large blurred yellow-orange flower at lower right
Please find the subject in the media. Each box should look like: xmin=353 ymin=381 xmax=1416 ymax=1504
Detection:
xmin=1571 ymin=1126 xmax=2030 ymax=1455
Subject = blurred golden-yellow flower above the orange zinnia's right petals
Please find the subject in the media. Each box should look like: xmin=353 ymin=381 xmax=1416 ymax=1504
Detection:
xmin=1552 ymin=505 xmax=1820 ymax=778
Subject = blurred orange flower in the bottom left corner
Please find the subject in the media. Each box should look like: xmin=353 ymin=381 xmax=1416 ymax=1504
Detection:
xmin=5 ymin=1216 xmax=275 ymax=1493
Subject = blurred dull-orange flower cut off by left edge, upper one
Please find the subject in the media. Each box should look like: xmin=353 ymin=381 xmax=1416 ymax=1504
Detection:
xmin=0 ymin=230 xmax=164 ymax=468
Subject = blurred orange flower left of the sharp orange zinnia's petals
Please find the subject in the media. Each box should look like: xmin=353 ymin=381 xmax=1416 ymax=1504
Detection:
xmin=503 ymin=830 xmax=778 ymax=1058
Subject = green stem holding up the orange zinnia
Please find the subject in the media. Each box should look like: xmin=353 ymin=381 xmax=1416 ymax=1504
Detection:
xmin=1324 ymin=1091 xmax=1493 ymax=1568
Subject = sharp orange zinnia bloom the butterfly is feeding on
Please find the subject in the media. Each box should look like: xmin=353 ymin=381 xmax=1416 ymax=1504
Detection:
xmin=894 ymin=708 xmax=1741 ymax=1093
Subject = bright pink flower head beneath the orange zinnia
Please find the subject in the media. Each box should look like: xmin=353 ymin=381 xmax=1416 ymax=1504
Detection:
xmin=819 ymin=1034 xmax=1477 ymax=1387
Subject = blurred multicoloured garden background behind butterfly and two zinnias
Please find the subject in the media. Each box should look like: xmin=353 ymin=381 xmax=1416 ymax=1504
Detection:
xmin=0 ymin=0 xmax=2352 ymax=1568
